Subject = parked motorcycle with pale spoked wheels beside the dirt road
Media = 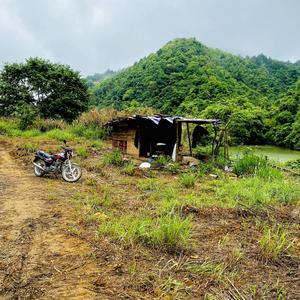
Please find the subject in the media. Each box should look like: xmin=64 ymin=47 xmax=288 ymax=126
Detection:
xmin=33 ymin=140 xmax=82 ymax=182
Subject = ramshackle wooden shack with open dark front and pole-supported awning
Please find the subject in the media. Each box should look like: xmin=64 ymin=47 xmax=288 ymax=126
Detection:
xmin=107 ymin=115 xmax=221 ymax=160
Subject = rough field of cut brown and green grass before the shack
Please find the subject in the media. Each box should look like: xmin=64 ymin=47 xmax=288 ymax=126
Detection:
xmin=0 ymin=121 xmax=300 ymax=299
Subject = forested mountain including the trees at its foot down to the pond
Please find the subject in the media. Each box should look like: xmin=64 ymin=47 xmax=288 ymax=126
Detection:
xmin=92 ymin=39 xmax=300 ymax=148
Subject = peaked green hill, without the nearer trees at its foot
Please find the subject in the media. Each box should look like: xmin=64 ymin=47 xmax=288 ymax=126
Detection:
xmin=94 ymin=39 xmax=300 ymax=113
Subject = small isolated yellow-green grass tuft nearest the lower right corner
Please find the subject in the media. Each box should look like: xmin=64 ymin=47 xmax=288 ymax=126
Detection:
xmin=259 ymin=227 xmax=295 ymax=261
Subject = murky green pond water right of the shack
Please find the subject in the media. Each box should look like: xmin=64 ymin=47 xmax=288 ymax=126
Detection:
xmin=229 ymin=146 xmax=300 ymax=163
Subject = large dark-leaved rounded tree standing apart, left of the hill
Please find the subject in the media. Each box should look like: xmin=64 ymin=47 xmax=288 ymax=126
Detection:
xmin=0 ymin=58 xmax=89 ymax=121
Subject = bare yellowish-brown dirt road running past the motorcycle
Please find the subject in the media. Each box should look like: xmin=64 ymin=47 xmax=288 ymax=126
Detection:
xmin=0 ymin=143 xmax=101 ymax=299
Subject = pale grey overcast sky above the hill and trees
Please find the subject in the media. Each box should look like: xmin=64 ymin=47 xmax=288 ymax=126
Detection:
xmin=0 ymin=0 xmax=300 ymax=76
